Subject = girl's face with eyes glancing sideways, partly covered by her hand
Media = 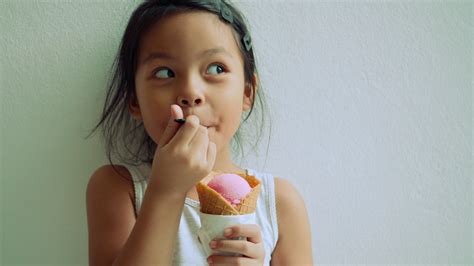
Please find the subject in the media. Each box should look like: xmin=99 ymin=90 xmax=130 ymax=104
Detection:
xmin=130 ymin=11 xmax=251 ymax=154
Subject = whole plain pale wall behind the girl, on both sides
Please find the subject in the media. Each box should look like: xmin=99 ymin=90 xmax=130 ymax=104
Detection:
xmin=0 ymin=0 xmax=474 ymax=265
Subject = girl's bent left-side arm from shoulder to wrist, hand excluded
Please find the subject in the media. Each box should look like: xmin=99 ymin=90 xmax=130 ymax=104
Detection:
xmin=87 ymin=166 xmax=185 ymax=266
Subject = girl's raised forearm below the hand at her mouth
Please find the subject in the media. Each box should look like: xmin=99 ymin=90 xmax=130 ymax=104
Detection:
xmin=113 ymin=185 xmax=186 ymax=265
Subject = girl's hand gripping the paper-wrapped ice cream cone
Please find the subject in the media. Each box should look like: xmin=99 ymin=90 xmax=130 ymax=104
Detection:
xmin=207 ymin=224 xmax=265 ymax=265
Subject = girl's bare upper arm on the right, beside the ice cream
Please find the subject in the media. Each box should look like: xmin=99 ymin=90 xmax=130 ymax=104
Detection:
xmin=271 ymin=178 xmax=313 ymax=265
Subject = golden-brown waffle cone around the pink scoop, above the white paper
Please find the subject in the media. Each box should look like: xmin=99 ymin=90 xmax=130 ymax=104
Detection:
xmin=196 ymin=172 xmax=260 ymax=215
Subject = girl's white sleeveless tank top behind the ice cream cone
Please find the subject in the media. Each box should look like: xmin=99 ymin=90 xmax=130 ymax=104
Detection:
xmin=124 ymin=165 xmax=278 ymax=265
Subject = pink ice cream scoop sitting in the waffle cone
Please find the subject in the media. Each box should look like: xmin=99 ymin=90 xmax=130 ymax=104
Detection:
xmin=207 ymin=174 xmax=252 ymax=206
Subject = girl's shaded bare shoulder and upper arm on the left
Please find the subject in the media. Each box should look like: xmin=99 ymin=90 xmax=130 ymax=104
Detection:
xmin=86 ymin=165 xmax=136 ymax=265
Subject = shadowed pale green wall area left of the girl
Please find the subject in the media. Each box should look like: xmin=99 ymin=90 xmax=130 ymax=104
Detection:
xmin=0 ymin=1 xmax=141 ymax=265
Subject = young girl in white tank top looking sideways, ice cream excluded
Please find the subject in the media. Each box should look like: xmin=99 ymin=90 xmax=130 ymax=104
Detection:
xmin=87 ymin=0 xmax=312 ymax=265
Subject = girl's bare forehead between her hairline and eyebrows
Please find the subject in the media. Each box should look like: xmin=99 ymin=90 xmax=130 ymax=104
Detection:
xmin=139 ymin=11 xmax=241 ymax=63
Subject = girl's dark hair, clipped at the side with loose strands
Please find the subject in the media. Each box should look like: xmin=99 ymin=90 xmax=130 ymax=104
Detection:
xmin=87 ymin=0 xmax=271 ymax=175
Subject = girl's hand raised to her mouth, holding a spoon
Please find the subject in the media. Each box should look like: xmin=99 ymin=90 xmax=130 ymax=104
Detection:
xmin=149 ymin=105 xmax=216 ymax=196
